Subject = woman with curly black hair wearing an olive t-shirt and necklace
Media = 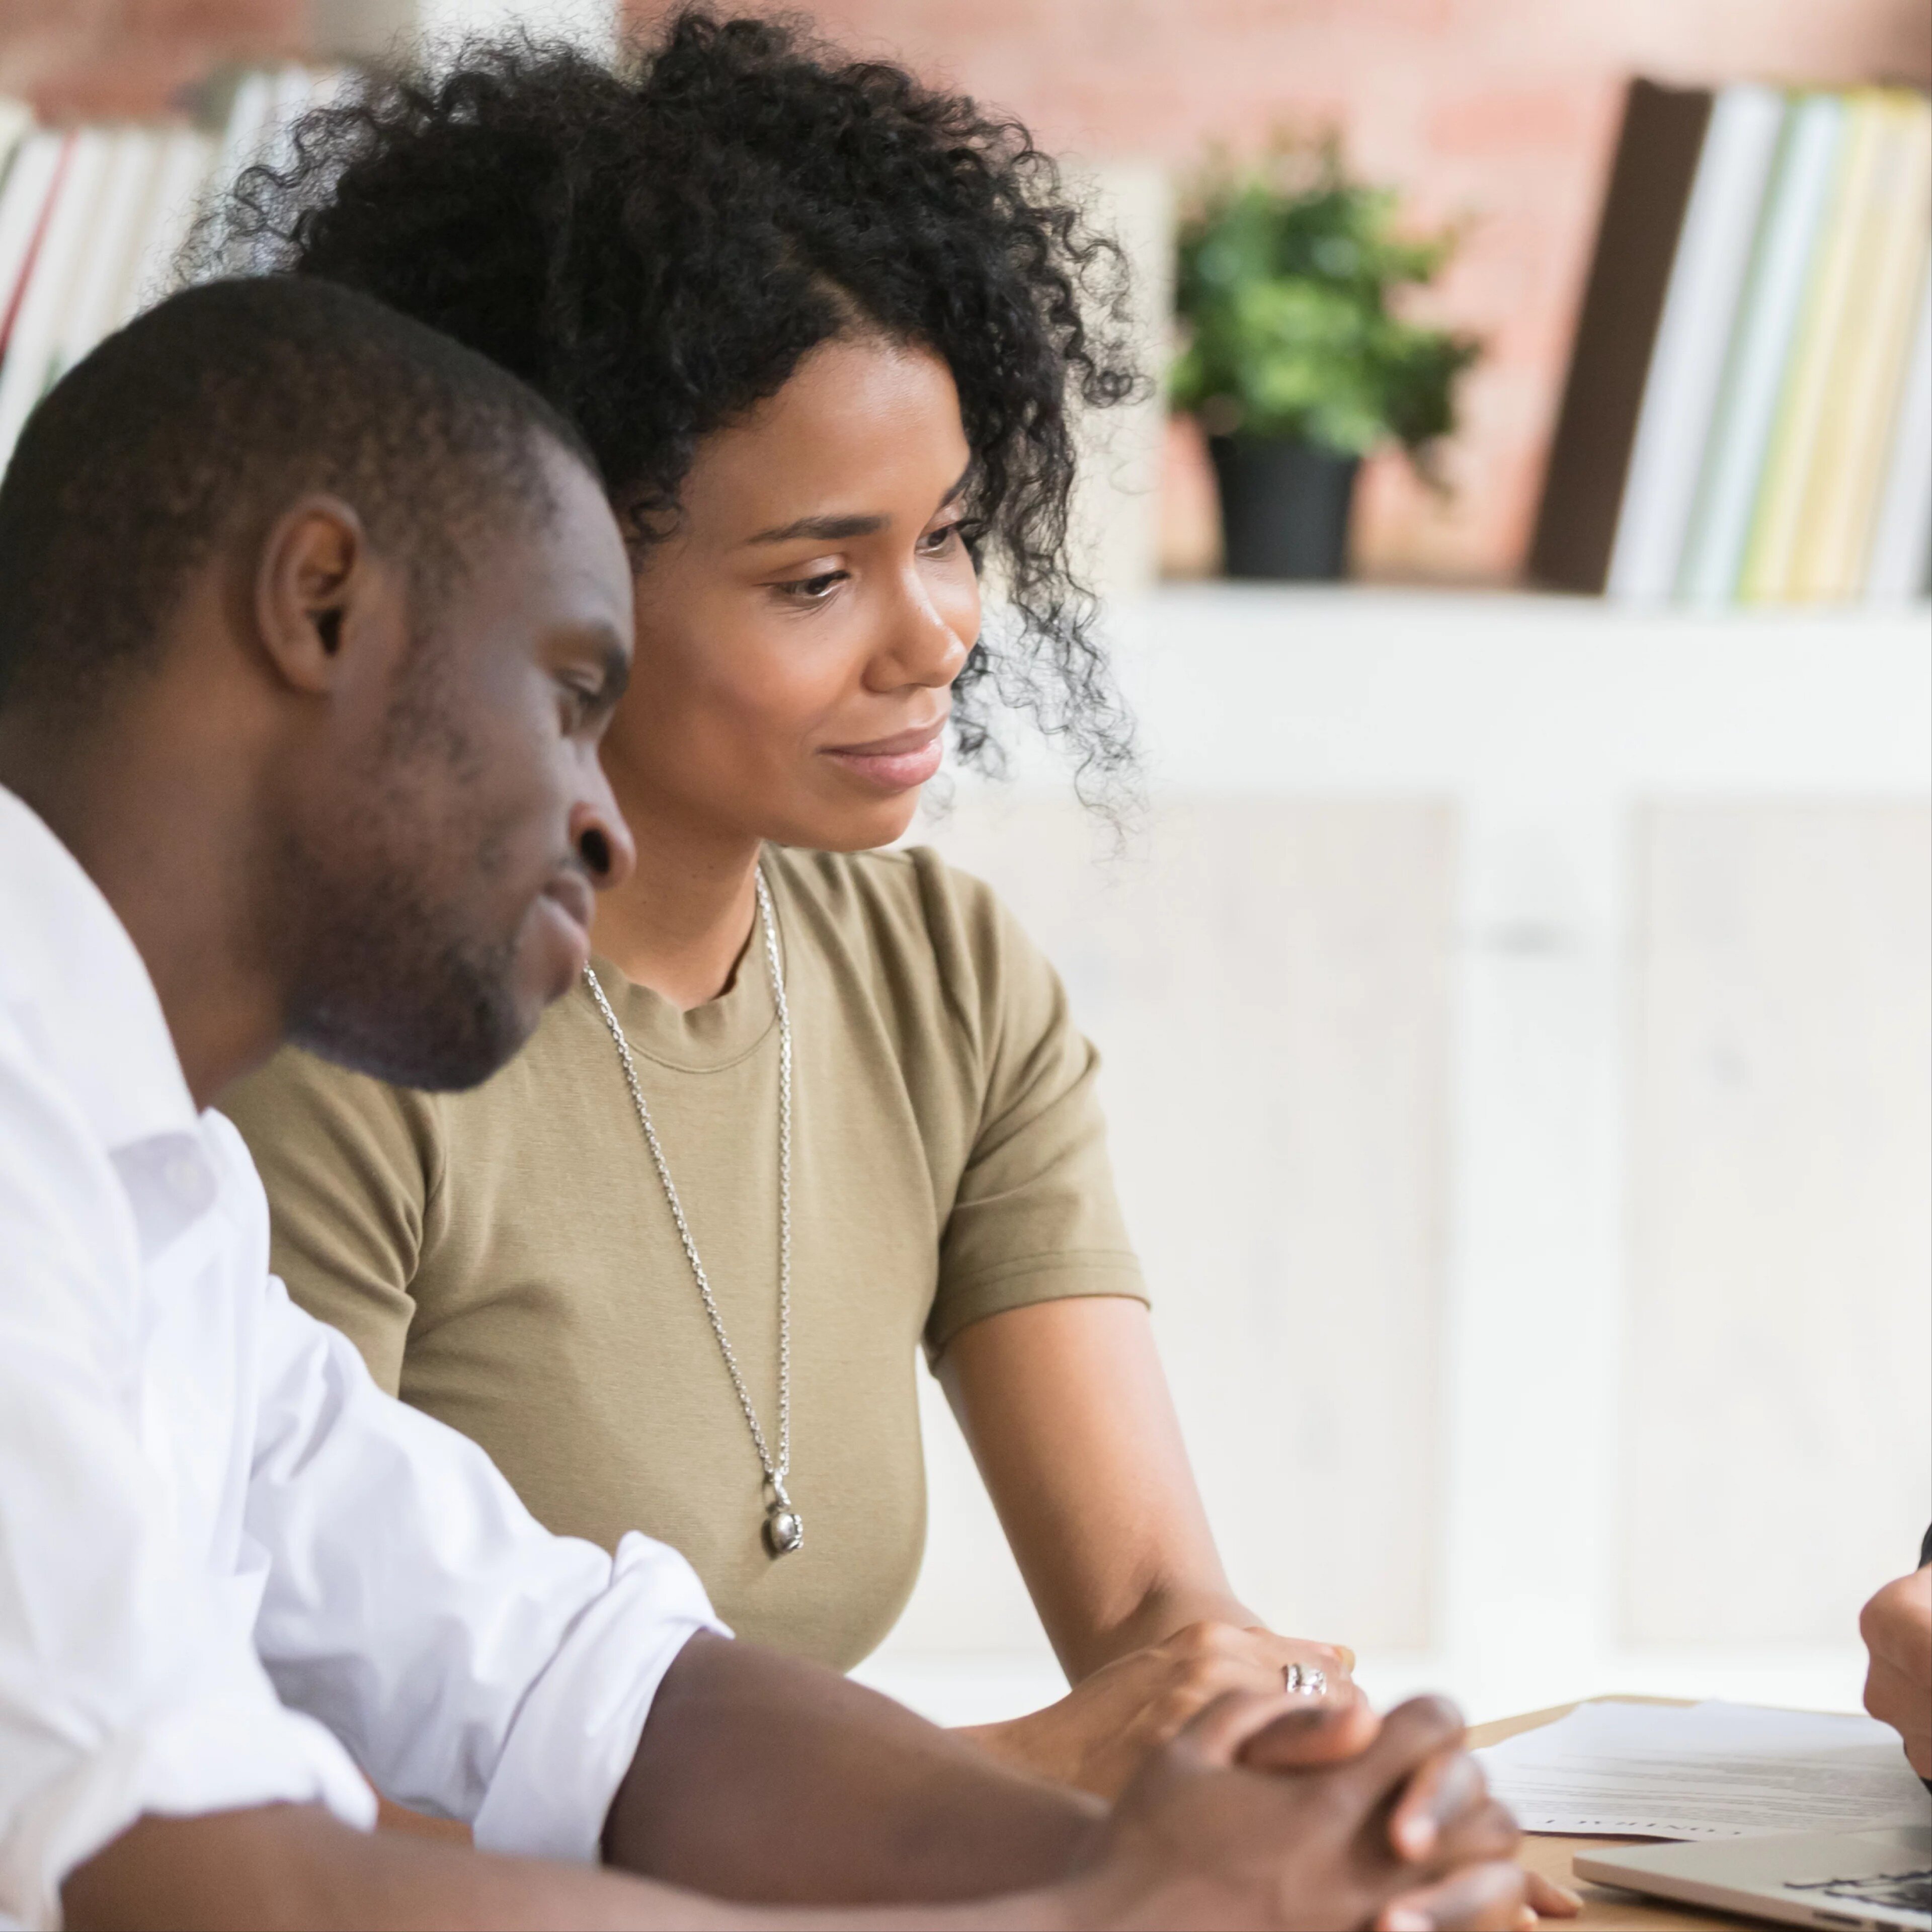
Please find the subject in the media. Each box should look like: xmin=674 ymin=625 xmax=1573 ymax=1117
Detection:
xmin=215 ymin=14 xmax=1346 ymax=1791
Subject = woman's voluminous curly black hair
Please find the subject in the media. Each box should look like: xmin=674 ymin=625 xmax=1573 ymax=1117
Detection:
xmin=207 ymin=8 xmax=1140 ymax=792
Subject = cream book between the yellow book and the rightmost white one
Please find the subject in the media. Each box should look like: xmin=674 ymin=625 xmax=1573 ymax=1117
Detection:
xmin=1785 ymin=93 xmax=1932 ymax=603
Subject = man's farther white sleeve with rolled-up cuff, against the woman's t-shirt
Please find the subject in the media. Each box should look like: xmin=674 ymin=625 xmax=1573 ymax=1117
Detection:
xmin=211 ymin=1120 xmax=729 ymax=1861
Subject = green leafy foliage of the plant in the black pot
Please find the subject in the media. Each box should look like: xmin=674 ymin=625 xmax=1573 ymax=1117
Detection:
xmin=1171 ymin=135 xmax=1480 ymax=475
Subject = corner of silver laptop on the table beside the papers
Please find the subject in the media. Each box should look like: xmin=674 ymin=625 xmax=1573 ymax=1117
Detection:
xmin=1576 ymin=1824 xmax=1932 ymax=1932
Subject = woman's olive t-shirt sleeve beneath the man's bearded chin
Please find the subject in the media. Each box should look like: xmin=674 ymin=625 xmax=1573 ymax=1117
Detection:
xmin=216 ymin=1047 xmax=439 ymax=1395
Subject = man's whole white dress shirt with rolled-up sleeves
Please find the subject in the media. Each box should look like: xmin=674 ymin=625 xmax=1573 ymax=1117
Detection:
xmin=0 ymin=788 xmax=720 ymax=1926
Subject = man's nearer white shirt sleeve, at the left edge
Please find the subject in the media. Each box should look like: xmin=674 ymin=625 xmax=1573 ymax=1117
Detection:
xmin=0 ymin=1059 xmax=375 ymax=1926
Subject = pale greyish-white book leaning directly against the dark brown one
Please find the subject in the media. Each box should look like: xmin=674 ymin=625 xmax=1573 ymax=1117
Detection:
xmin=1607 ymin=87 xmax=1785 ymax=603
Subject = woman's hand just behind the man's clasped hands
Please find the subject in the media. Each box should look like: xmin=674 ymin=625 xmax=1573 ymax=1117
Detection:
xmin=964 ymin=1623 xmax=1354 ymax=1799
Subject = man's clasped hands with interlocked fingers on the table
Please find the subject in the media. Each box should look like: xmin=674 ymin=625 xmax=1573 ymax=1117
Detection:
xmin=1069 ymin=1695 xmax=1524 ymax=1932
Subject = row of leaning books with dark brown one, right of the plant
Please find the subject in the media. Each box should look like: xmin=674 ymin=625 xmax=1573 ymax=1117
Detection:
xmin=1530 ymin=81 xmax=1932 ymax=607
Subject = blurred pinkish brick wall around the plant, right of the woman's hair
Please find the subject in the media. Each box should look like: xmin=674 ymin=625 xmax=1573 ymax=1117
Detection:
xmin=639 ymin=0 xmax=1932 ymax=578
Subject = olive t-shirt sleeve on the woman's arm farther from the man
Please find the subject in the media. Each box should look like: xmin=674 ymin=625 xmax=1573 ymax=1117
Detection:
xmin=914 ymin=852 xmax=1148 ymax=1356
